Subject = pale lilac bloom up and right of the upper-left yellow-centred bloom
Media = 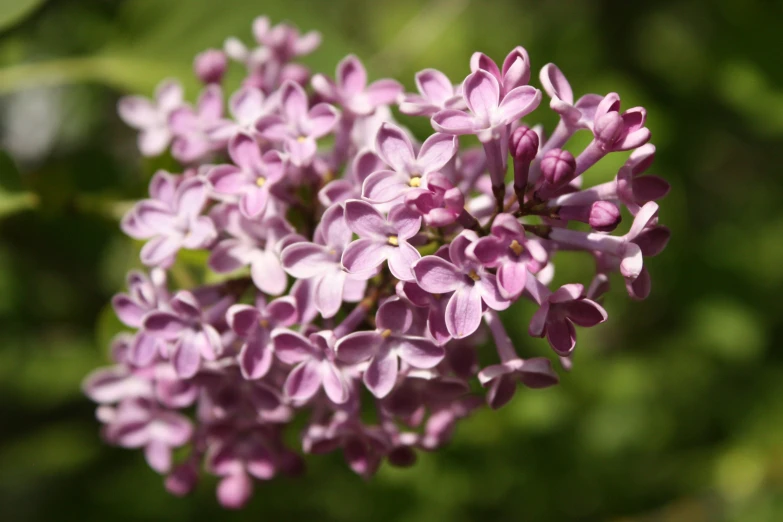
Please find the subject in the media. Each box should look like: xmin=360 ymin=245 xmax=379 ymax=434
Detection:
xmin=256 ymin=81 xmax=339 ymax=166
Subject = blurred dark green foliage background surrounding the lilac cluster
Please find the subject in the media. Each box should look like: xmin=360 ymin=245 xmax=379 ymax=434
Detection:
xmin=0 ymin=0 xmax=783 ymax=522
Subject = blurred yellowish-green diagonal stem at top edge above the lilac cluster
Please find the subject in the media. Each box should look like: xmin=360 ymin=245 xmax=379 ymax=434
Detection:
xmin=369 ymin=0 xmax=470 ymax=76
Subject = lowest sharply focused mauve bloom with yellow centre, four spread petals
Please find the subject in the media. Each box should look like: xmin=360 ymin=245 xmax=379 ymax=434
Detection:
xmin=337 ymin=299 xmax=446 ymax=398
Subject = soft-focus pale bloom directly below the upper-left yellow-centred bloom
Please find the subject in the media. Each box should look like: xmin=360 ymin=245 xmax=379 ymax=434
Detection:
xmin=207 ymin=205 xmax=305 ymax=295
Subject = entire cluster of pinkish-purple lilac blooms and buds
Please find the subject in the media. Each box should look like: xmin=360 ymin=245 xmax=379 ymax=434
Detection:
xmin=84 ymin=17 xmax=669 ymax=508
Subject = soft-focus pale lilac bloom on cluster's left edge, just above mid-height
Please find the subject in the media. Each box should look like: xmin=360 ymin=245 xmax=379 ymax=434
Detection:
xmin=133 ymin=178 xmax=217 ymax=266
